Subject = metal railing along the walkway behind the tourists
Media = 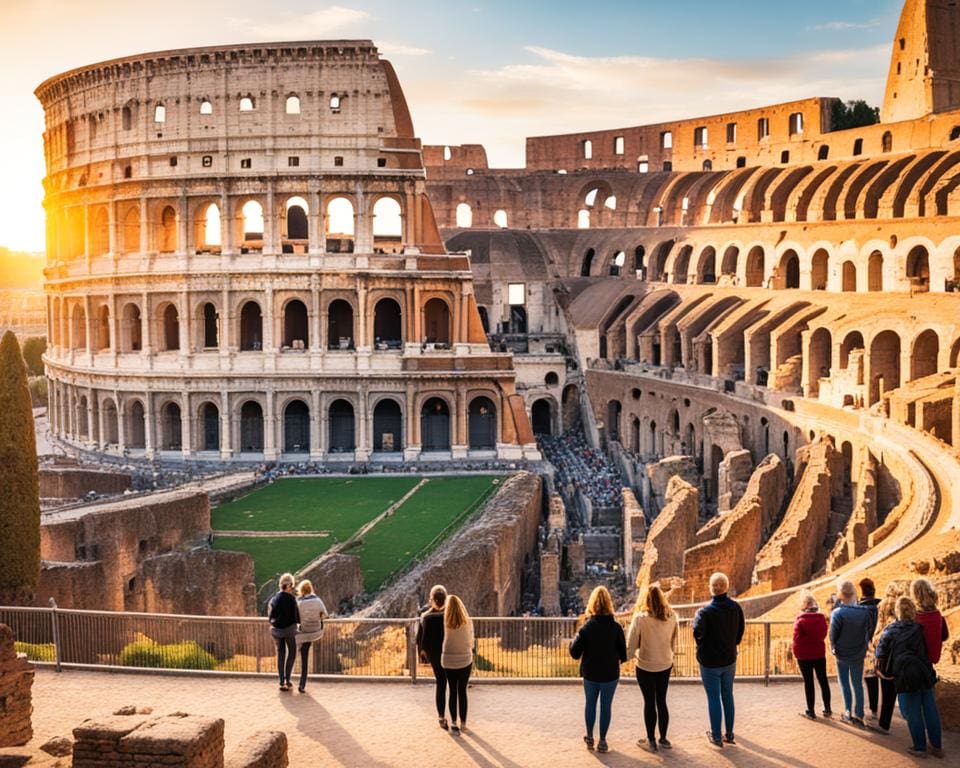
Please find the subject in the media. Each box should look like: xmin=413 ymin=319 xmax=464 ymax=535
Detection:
xmin=0 ymin=604 xmax=816 ymax=681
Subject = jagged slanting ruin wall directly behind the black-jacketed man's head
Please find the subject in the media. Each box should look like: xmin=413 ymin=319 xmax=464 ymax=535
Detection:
xmin=683 ymin=454 xmax=787 ymax=602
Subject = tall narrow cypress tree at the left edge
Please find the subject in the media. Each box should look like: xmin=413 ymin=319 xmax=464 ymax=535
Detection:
xmin=0 ymin=331 xmax=40 ymax=605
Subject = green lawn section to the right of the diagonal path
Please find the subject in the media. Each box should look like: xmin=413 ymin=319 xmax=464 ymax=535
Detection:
xmin=350 ymin=476 xmax=503 ymax=593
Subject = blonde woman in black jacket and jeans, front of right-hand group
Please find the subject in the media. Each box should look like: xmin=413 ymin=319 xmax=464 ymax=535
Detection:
xmin=877 ymin=596 xmax=943 ymax=757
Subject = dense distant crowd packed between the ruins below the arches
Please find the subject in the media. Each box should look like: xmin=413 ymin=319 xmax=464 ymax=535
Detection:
xmin=540 ymin=432 xmax=623 ymax=508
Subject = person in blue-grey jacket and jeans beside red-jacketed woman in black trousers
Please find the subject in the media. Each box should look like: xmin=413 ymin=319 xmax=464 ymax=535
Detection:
xmin=830 ymin=581 xmax=874 ymax=728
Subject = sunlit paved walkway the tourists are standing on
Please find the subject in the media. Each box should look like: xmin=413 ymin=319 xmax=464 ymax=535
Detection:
xmin=18 ymin=669 xmax=960 ymax=768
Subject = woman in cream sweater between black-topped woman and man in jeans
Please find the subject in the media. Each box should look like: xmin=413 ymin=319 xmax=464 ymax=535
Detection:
xmin=627 ymin=584 xmax=677 ymax=752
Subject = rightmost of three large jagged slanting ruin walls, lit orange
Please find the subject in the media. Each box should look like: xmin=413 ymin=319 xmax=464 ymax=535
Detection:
xmin=753 ymin=438 xmax=842 ymax=590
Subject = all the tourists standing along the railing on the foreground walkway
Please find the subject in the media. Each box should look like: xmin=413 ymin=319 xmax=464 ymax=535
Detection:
xmin=268 ymin=573 xmax=949 ymax=758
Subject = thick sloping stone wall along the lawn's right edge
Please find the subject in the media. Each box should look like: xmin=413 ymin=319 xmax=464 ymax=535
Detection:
xmin=361 ymin=472 xmax=543 ymax=617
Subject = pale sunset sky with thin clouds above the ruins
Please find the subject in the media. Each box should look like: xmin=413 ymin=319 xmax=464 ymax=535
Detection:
xmin=0 ymin=0 xmax=902 ymax=250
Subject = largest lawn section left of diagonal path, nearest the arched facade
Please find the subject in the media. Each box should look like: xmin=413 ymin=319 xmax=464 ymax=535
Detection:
xmin=211 ymin=476 xmax=420 ymax=541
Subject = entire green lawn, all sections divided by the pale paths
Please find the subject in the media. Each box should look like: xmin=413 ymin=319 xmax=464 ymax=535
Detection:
xmin=211 ymin=475 xmax=505 ymax=592
